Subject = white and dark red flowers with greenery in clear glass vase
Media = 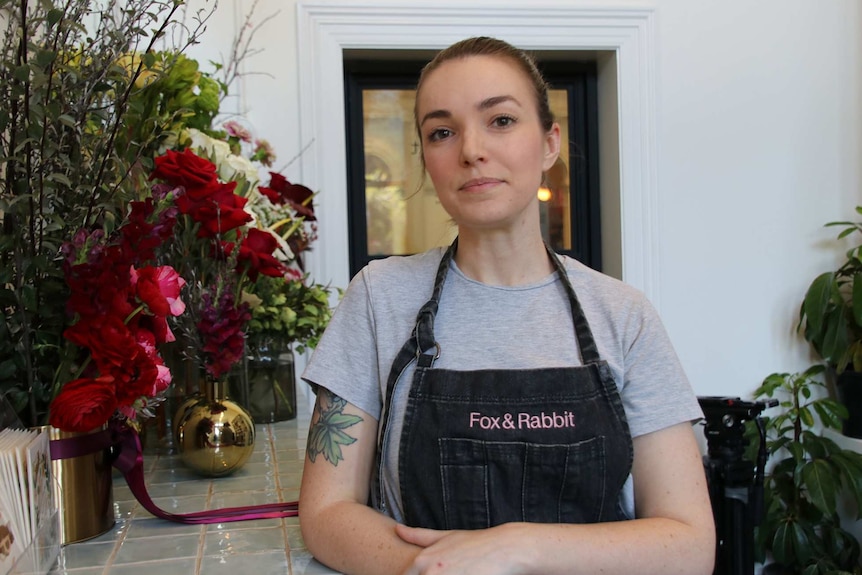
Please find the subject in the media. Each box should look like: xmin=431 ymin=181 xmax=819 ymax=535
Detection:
xmin=176 ymin=125 xmax=331 ymax=422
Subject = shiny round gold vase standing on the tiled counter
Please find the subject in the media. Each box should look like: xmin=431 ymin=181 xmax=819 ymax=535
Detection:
xmin=174 ymin=381 xmax=254 ymax=477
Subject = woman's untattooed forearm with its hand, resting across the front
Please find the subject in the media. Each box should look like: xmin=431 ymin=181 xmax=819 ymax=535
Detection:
xmin=398 ymin=518 xmax=715 ymax=575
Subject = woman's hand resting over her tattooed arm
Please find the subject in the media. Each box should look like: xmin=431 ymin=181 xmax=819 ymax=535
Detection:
xmin=395 ymin=523 xmax=531 ymax=575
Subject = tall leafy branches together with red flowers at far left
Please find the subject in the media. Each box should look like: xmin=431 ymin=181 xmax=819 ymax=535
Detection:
xmin=0 ymin=0 xmax=216 ymax=429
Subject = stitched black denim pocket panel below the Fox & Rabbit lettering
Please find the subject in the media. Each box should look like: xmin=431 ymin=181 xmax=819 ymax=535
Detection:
xmin=438 ymin=436 xmax=605 ymax=529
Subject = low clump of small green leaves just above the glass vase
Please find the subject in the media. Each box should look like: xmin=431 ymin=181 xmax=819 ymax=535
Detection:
xmin=247 ymin=276 xmax=340 ymax=353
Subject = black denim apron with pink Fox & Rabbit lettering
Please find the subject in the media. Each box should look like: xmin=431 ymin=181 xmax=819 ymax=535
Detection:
xmin=374 ymin=243 xmax=633 ymax=529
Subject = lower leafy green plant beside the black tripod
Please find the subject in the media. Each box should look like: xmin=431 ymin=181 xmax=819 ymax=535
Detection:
xmin=752 ymin=365 xmax=862 ymax=575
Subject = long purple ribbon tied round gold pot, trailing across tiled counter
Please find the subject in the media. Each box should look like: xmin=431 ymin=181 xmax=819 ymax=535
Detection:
xmin=50 ymin=421 xmax=299 ymax=524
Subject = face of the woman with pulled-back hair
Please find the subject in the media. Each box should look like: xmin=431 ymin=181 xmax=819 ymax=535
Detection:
xmin=416 ymin=56 xmax=560 ymax=234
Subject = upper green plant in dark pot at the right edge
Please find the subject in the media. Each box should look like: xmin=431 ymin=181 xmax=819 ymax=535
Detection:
xmin=799 ymin=207 xmax=862 ymax=438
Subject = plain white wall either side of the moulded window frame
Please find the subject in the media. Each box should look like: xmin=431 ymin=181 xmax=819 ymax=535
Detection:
xmin=187 ymin=0 xmax=862 ymax=404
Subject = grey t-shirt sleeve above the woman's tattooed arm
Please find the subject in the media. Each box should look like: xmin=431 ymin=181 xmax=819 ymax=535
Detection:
xmin=302 ymin=270 xmax=381 ymax=419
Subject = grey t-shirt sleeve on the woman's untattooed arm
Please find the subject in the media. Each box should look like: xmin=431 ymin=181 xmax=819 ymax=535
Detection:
xmin=622 ymin=297 xmax=703 ymax=437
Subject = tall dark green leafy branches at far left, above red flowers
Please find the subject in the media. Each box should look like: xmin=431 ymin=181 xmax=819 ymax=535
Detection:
xmin=0 ymin=0 xmax=215 ymax=425
